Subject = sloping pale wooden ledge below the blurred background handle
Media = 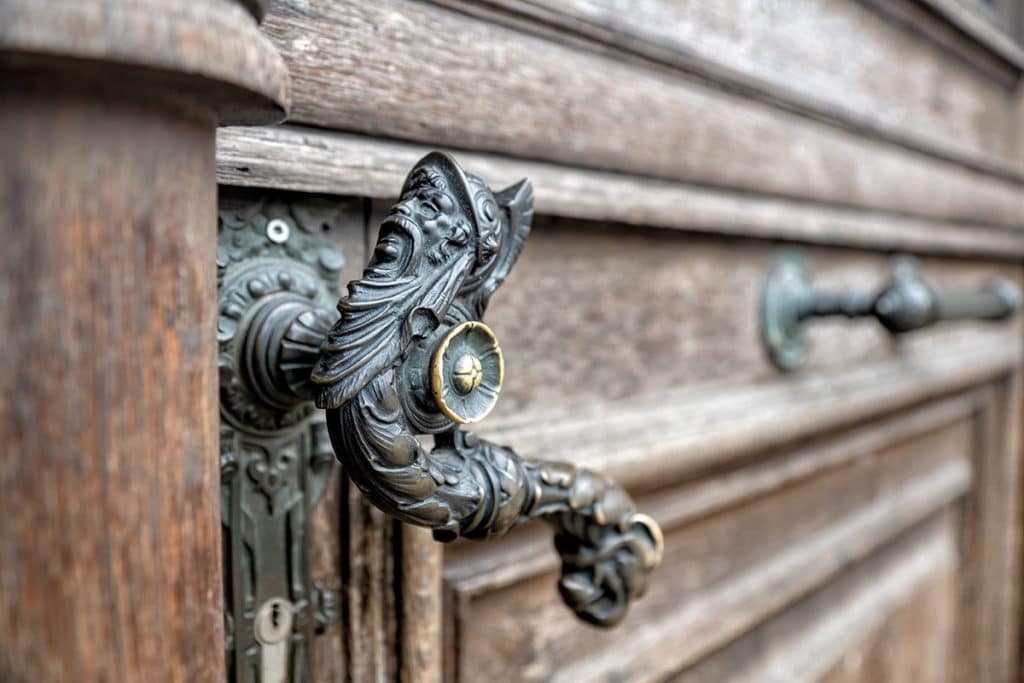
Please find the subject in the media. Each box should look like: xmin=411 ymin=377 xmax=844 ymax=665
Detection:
xmin=480 ymin=327 xmax=1019 ymax=488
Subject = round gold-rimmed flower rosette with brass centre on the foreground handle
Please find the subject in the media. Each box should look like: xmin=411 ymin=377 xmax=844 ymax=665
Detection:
xmin=430 ymin=321 xmax=505 ymax=424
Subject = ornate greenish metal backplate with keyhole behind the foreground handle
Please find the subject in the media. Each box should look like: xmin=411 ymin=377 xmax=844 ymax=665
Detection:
xmin=217 ymin=194 xmax=344 ymax=683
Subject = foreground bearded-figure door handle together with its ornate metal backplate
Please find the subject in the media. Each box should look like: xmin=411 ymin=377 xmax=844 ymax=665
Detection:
xmin=218 ymin=153 xmax=663 ymax=676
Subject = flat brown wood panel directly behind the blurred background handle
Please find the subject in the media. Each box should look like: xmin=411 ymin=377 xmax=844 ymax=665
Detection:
xmin=475 ymin=227 xmax=1024 ymax=422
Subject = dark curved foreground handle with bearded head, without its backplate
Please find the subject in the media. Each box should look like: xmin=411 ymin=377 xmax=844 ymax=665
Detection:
xmin=234 ymin=153 xmax=663 ymax=626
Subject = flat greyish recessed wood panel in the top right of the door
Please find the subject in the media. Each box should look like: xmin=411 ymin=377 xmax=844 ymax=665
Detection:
xmin=435 ymin=0 xmax=1024 ymax=172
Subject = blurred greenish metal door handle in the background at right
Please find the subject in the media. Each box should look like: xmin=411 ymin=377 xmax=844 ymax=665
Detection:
xmin=761 ymin=254 xmax=1020 ymax=370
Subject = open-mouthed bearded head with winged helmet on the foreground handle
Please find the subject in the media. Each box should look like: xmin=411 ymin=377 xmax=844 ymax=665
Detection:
xmin=312 ymin=153 xmax=532 ymax=408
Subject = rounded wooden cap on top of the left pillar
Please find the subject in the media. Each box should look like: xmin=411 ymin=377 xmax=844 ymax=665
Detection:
xmin=0 ymin=0 xmax=290 ymax=124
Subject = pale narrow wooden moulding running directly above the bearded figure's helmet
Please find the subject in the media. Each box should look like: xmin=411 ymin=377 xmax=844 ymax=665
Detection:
xmin=217 ymin=126 xmax=1024 ymax=259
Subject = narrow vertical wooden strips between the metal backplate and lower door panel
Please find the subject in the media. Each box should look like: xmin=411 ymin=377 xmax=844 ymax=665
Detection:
xmin=313 ymin=193 xmax=442 ymax=683
